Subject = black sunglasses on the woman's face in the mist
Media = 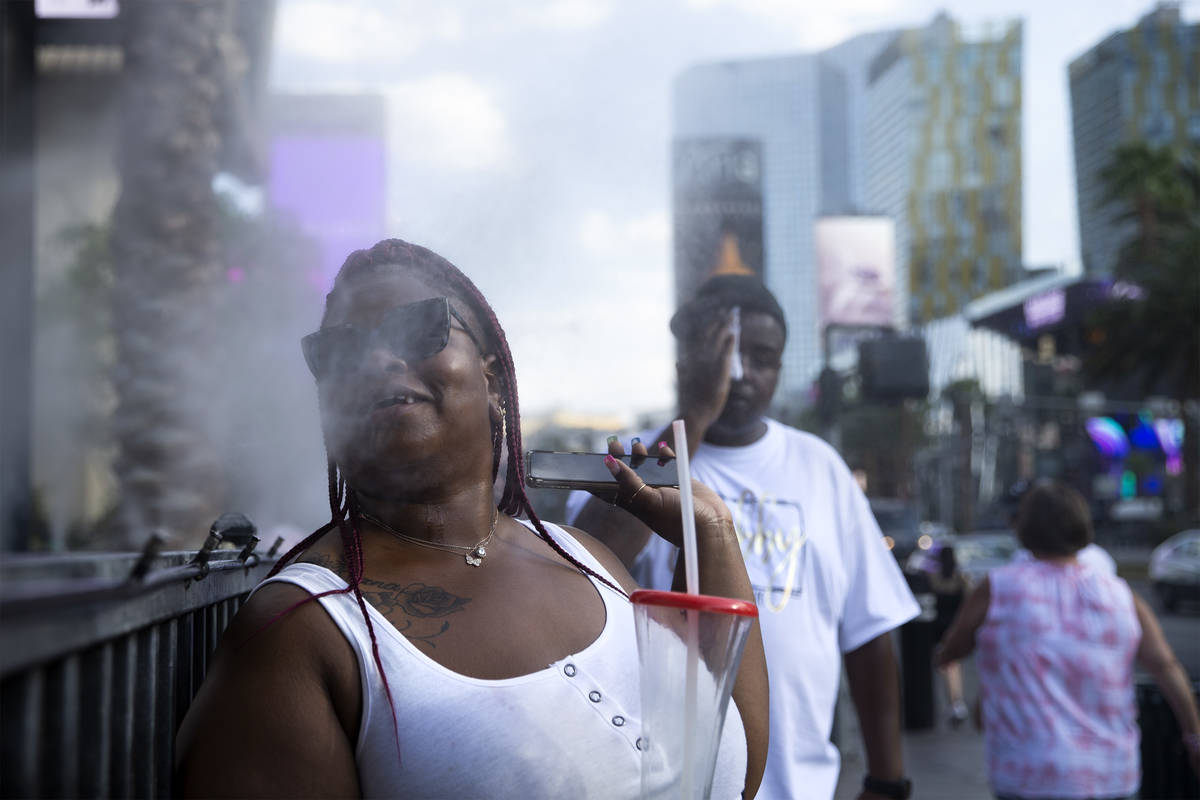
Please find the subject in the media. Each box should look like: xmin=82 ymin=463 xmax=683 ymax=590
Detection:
xmin=300 ymin=297 xmax=482 ymax=380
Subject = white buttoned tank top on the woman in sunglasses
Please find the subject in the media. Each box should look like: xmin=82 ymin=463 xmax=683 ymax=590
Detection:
xmin=259 ymin=523 xmax=746 ymax=800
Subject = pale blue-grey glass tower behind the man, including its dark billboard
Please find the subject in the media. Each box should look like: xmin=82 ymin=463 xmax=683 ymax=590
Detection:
xmin=672 ymin=32 xmax=892 ymax=404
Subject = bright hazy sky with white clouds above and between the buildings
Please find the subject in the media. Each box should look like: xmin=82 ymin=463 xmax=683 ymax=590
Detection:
xmin=270 ymin=0 xmax=1200 ymax=417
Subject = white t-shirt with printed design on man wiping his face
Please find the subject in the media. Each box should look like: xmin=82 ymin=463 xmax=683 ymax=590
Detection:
xmin=569 ymin=420 xmax=919 ymax=800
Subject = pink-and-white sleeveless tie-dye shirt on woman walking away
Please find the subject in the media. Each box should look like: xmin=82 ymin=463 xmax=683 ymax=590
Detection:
xmin=977 ymin=561 xmax=1141 ymax=798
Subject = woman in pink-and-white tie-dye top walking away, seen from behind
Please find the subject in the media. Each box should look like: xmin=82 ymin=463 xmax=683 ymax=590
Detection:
xmin=936 ymin=483 xmax=1200 ymax=798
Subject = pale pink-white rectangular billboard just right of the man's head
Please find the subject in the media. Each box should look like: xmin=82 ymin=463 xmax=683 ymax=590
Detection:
xmin=815 ymin=217 xmax=896 ymax=330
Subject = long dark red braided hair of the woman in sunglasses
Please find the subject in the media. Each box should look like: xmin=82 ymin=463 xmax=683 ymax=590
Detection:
xmin=268 ymin=239 xmax=625 ymax=747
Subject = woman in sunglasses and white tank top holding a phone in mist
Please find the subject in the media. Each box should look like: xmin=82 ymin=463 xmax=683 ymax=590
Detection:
xmin=176 ymin=240 xmax=767 ymax=798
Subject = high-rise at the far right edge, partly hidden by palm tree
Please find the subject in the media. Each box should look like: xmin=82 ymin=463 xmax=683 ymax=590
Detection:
xmin=1068 ymin=4 xmax=1200 ymax=275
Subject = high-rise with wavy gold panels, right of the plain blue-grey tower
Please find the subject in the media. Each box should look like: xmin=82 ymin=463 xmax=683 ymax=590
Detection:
xmin=864 ymin=13 xmax=1024 ymax=323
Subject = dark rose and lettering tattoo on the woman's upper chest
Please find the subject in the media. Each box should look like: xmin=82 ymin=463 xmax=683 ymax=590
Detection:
xmin=305 ymin=553 xmax=470 ymax=649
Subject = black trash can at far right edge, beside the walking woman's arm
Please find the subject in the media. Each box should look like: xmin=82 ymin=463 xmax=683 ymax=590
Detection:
xmin=1138 ymin=680 xmax=1200 ymax=800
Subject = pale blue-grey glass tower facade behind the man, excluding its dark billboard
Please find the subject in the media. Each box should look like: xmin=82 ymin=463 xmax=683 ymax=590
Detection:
xmin=672 ymin=32 xmax=892 ymax=404
